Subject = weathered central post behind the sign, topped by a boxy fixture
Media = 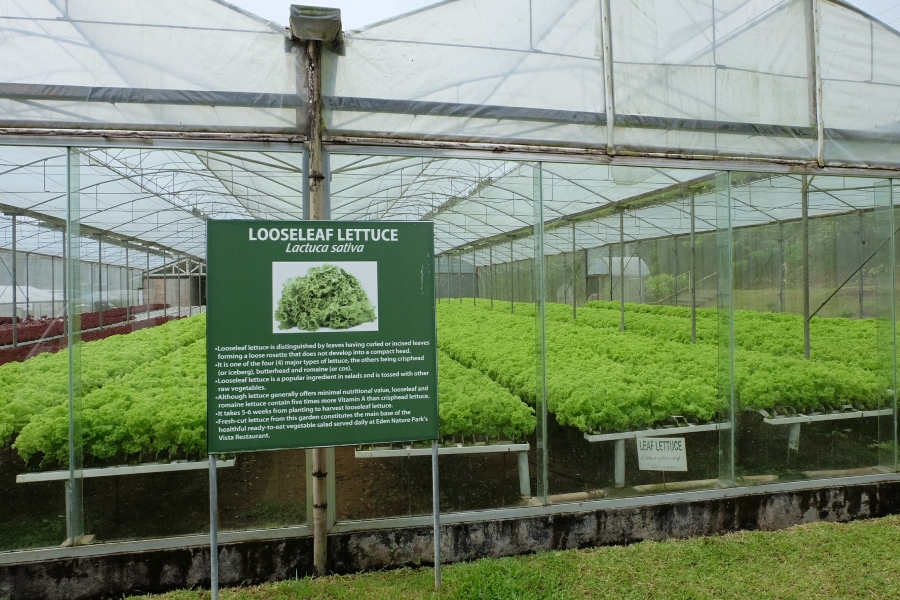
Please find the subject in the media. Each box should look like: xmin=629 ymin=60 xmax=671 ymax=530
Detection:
xmin=306 ymin=40 xmax=328 ymax=575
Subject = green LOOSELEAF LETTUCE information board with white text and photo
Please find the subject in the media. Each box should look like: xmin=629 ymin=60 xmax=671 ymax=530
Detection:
xmin=207 ymin=221 xmax=438 ymax=453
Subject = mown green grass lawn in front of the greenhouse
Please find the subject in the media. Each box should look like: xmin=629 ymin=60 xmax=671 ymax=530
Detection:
xmin=134 ymin=516 xmax=900 ymax=600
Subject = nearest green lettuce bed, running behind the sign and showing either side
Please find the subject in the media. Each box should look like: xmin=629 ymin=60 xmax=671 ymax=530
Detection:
xmin=0 ymin=315 xmax=535 ymax=466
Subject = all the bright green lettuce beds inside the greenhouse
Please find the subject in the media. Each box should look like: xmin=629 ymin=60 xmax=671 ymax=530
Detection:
xmin=0 ymin=300 xmax=892 ymax=466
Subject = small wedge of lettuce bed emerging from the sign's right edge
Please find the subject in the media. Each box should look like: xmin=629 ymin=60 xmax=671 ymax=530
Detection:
xmin=438 ymin=352 xmax=537 ymax=441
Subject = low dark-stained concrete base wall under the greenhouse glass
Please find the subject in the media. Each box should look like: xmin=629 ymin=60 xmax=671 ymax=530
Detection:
xmin=0 ymin=482 xmax=900 ymax=600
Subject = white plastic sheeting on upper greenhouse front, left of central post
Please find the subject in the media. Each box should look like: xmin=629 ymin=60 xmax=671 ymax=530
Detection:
xmin=0 ymin=0 xmax=306 ymax=133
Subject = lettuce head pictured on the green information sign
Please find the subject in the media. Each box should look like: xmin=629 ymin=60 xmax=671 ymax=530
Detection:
xmin=275 ymin=265 xmax=375 ymax=331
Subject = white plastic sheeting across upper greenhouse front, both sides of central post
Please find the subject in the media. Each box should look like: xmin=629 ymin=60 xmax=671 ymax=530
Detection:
xmin=0 ymin=0 xmax=900 ymax=168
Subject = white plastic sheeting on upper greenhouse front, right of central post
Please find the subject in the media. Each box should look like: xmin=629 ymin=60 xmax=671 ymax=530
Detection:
xmin=323 ymin=0 xmax=900 ymax=167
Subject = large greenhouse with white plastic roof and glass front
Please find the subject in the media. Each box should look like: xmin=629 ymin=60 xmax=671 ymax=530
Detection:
xmin=0 ymin=0 xmax=900 ymax=597
